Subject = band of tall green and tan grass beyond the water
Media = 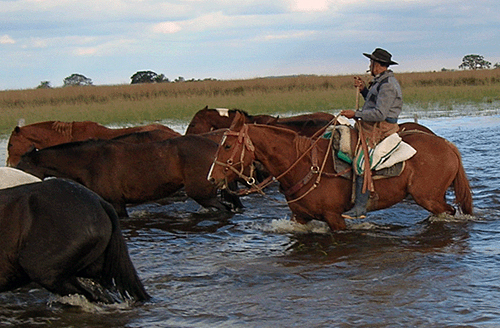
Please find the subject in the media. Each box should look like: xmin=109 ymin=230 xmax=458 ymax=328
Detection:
xmin=0 ymin=69 xmax=500 ymax=134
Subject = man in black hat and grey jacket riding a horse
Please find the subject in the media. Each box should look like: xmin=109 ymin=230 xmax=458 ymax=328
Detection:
xmin=340 ymin=48 xmax=403 ymax=219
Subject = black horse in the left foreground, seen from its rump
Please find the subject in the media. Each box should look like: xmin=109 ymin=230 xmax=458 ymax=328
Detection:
xmin=0 ymin=179 xmax=149 ymax=303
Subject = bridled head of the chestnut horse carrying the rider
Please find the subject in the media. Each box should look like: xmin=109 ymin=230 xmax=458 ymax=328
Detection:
xmin=207 ymin=112 xmax=255 ymax=188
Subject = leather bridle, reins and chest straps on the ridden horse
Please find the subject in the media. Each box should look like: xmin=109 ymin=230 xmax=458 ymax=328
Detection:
xmin=214 ymin=116 xmax=351 ymax=203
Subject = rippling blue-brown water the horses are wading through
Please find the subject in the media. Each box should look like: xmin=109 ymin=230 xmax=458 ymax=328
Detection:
xmin=0 ymin=112 xmax=500 ymax=328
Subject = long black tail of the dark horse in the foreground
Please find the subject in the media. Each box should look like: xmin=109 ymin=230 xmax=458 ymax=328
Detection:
xmin=101 ymin=201 xmax=151 ymax=302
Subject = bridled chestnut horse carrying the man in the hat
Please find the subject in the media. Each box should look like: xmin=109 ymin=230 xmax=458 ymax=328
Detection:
xmin=208 ymin=116 xmax=472 ymax=230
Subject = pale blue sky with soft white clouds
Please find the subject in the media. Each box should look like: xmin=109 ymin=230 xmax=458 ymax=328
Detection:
xmin=0 ymin=0 xmax=500 ymax=90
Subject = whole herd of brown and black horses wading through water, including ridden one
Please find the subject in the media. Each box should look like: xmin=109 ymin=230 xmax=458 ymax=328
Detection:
xmin=0 ymin=108 xmax=472 ymax=303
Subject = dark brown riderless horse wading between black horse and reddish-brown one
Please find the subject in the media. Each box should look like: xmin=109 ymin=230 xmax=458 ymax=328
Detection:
xmin=17 ymin=135 xmax=241 ymax=216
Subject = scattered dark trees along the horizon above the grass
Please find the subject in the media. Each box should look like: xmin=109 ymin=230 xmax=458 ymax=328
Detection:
xmin=37 ymin=54 xmax=500 ymax=89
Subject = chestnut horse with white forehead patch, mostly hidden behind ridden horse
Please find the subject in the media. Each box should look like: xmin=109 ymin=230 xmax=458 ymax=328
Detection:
xmin=186 ymin=107 xmax=433 ymax=137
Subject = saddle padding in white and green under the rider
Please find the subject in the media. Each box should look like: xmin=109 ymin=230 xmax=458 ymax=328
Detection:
xmin=323 ymin=124 xmax=416 ymax=179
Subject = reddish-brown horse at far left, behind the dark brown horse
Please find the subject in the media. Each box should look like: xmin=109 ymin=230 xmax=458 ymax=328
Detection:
xmin=7 ymin=121 xmax=180 ymax=166
